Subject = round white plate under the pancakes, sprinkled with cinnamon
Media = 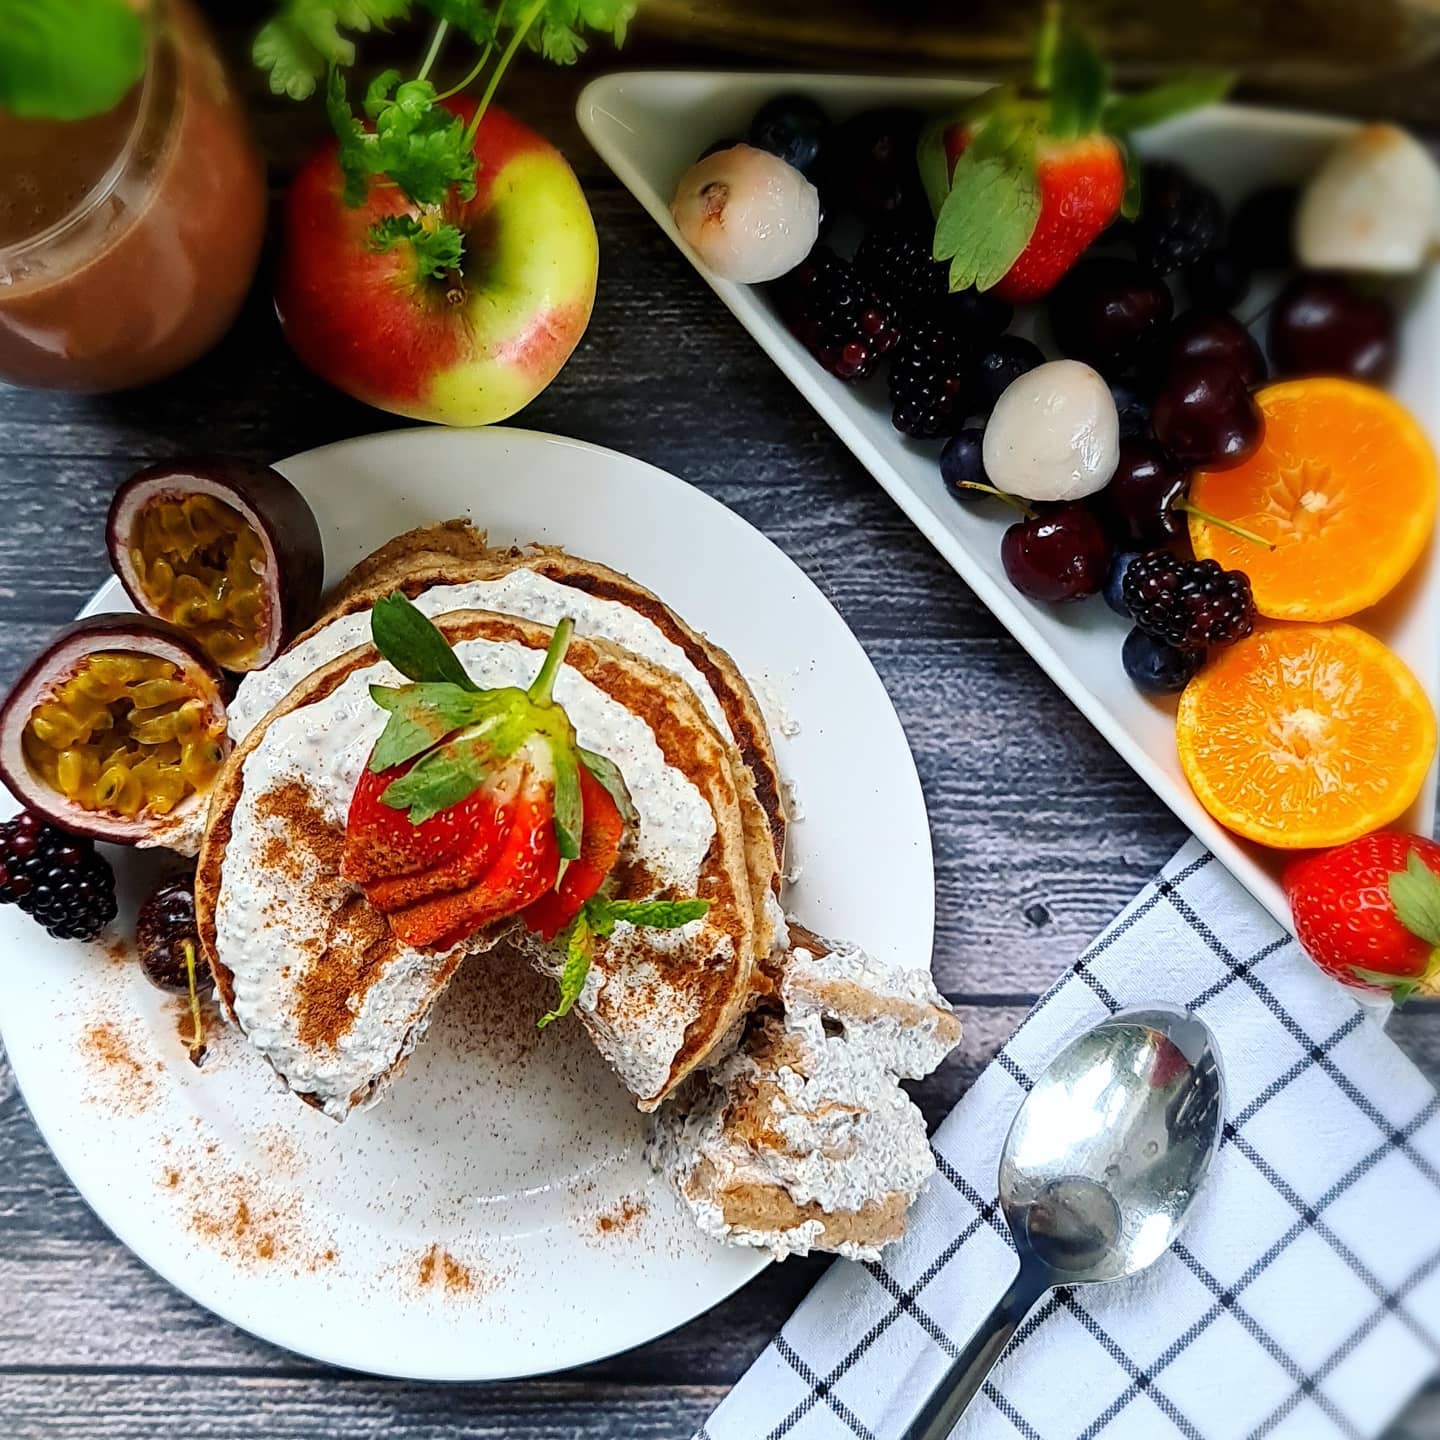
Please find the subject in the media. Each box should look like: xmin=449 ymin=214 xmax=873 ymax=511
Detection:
xmin=0 ymin=429 xmax=935 ymax=1381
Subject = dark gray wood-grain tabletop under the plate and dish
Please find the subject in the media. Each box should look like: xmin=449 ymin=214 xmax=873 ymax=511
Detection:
xmin=0 ymin=25 xmax=1440 ymax=1440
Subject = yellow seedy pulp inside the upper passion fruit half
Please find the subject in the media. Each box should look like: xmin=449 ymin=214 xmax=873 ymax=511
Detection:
xmin=130 ymin=495 xmax=271 ymax=671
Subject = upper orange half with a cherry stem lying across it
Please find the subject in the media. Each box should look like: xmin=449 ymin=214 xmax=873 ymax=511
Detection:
xmin=1189 ymin=379 xmax=1437 ymax=621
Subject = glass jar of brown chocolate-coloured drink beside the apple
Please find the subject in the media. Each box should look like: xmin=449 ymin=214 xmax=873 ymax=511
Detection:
xmin=0 ymin=0 xmax=265 ymax=390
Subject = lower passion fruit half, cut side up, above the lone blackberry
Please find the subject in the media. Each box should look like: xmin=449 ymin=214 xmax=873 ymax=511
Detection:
xmin=0 ymin=615 xmax=230 ymax=854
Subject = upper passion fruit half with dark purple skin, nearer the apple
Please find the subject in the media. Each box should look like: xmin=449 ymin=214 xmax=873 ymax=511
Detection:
xmin=107 ymin=456 xmax=325 ymax=672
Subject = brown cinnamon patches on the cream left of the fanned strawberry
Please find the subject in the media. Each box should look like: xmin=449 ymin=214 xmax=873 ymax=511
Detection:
xmin=255 ymin=780 xmax=396 ymax=1048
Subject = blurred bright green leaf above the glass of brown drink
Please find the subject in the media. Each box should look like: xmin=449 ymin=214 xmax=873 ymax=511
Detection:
xmin=0 ymin=0 xmax=145 ymax=120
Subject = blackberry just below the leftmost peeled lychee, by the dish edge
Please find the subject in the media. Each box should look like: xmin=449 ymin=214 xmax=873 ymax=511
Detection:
xmin=775 ymin=245 xmax=900 ymax=380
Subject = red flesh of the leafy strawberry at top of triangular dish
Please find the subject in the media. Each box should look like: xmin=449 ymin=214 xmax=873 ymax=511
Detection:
xmin=995 ymin=135 xmax=1125 ymax=304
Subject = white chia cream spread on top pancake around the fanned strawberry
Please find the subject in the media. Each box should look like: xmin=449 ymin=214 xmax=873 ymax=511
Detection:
xmin=215 ymin=636 xmax=716 ymax=1119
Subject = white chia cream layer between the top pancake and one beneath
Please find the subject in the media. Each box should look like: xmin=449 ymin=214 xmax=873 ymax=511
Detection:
xmin=237 ymin=566 xmax=730 ymax=744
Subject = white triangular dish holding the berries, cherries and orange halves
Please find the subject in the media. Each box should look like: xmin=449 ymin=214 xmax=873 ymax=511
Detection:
xmin=576 ymin=71 xmax=1440 ymax=927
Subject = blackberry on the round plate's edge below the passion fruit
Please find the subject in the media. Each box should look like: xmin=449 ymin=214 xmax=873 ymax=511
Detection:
xmin=0 ymin=811 xmax=115 ymax=940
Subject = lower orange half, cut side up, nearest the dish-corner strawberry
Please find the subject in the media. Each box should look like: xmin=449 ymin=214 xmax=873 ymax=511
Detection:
xmin=1175 ymin=625 xmax=1436 ymax=850
